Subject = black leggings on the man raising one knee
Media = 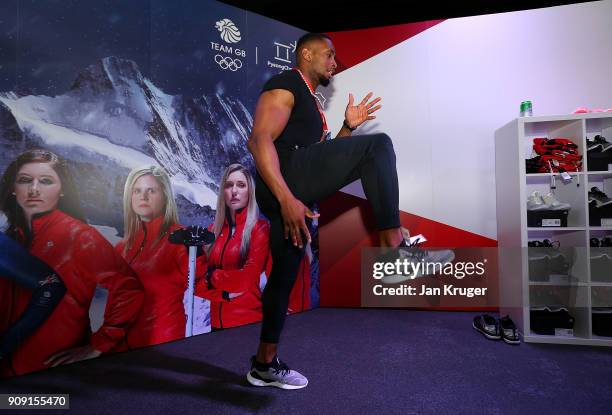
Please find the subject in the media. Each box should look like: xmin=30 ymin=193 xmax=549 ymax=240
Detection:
xmin=256 ymin=134 xmax=400 ymax=343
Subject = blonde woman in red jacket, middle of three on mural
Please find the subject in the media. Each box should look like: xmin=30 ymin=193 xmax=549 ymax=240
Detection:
xmin=115 ymin=166 xmax=206 ymax=348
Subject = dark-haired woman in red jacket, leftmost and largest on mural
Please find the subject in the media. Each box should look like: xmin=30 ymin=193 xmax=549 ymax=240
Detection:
xmin=0 ymin=150 xmax=143 ymax=376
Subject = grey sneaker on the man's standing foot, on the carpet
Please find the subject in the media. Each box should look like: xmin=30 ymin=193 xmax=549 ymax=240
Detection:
xmin=247 ymin=356 xmax=308 ymax=389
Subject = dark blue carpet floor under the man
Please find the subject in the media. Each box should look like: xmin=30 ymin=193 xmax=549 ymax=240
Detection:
xmin=0 ymin=308 xmax=612 ymax=415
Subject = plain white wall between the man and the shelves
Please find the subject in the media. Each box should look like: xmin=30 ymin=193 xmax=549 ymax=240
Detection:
xmin=321 ymin=0 xmax=612 ymax=239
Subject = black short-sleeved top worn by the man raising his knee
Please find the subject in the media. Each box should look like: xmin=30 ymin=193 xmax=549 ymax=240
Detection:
xmin=262 ymin=70 xmax=323 ymax=157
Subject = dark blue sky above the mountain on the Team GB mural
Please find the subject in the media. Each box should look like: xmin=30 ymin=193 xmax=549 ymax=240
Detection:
xmin=0 ymin=0 xmax=303 ymax=110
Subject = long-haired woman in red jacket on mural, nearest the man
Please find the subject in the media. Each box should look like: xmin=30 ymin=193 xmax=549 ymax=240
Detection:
xmin=196 ymin=164 xmax=270 ymax=329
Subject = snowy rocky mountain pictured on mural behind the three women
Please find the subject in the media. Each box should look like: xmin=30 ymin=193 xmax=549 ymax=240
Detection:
xmin=0 ymin=57 xmax=253 ymax=234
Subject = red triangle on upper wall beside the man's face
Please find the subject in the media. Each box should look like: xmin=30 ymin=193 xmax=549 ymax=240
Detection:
xmin=327 ymin=20 xmax=444 ymax=73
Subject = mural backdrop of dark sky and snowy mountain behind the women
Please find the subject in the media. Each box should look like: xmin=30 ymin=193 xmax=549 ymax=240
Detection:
xmin=0 ymin=0 xmax=318 ymax=374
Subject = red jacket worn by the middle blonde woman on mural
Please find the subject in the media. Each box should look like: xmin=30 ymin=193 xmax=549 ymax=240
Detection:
xmin=115 ymin=216 xmax=206 ymax=348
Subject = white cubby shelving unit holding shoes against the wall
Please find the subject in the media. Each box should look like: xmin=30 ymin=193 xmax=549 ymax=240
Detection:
xmin=495 ymin=113 xmax=612 ymax=346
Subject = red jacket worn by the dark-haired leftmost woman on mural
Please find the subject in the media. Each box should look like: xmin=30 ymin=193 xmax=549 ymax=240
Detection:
xmin=0 ymin=210 xmax=144 ymax=376
